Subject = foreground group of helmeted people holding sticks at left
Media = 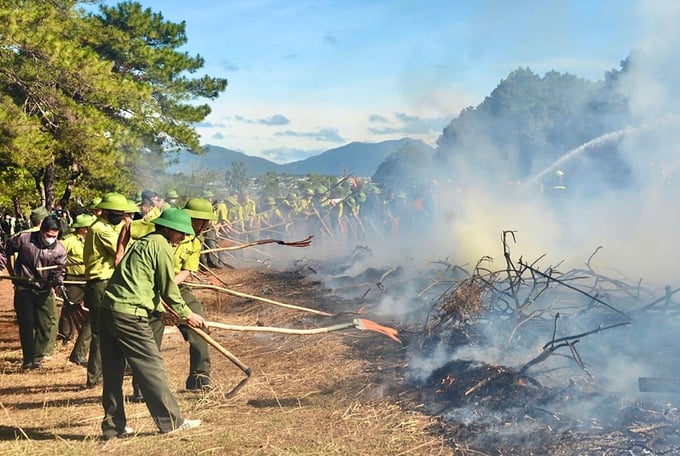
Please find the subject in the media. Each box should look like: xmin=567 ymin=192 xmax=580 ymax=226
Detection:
xmin=0 ymin=191 xmax=217 ymax=440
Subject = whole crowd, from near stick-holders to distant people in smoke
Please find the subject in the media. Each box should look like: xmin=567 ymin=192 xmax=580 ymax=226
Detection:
xmin=0 ymin=180 xmax=440 ymax=439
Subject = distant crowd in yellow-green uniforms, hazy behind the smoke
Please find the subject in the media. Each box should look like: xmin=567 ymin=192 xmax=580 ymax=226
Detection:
xmin=197 ymin=179 xmax=435 ymax=256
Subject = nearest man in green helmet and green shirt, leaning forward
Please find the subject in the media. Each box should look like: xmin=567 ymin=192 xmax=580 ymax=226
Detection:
xmin=100 ymin=208 xmax=205 ymax=440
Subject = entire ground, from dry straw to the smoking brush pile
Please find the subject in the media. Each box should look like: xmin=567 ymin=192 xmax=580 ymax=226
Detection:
xmin=0 ymin=237 xmax=680 ymax=456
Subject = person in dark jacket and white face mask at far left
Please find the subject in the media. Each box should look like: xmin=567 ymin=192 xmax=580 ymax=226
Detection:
xmin=0 ymin=217 xmax=66 ymax=369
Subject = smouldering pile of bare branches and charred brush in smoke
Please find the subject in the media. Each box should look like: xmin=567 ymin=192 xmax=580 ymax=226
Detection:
xmin=398 ymin=232 xmax=680 ymax=455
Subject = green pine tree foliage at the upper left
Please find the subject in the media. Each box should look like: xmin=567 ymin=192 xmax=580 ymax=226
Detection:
xmin=0 ymin=0 xmax=227 ymax=215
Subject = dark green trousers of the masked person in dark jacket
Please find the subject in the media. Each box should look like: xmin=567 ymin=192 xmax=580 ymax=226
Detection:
xmin=14 ymin=287 xmax=57 ymax=363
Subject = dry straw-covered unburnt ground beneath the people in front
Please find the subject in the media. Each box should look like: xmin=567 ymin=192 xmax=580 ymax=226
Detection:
xmin=0 ymin=265 xmax=456 ymax=455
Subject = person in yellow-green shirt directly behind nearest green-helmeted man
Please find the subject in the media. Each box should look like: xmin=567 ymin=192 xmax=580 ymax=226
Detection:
xmin=83 ymin=192 xmax=128 ymax=388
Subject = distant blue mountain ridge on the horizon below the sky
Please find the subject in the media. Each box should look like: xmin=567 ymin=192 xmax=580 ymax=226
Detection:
xmin=168 ymin=138 xmax=434 ymax=177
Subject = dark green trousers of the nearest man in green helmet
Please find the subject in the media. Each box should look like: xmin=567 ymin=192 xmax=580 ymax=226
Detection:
xmin=99 ymin=309 xmax=184 ymax=437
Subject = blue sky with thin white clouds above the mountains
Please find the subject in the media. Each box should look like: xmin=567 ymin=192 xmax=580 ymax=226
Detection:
xmin=115 ymin=0 xmax=654 ymax=163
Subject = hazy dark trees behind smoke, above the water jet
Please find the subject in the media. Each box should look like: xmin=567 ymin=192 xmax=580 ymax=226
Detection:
xmin=437 ymin=61 xmax=630 ymax=188
